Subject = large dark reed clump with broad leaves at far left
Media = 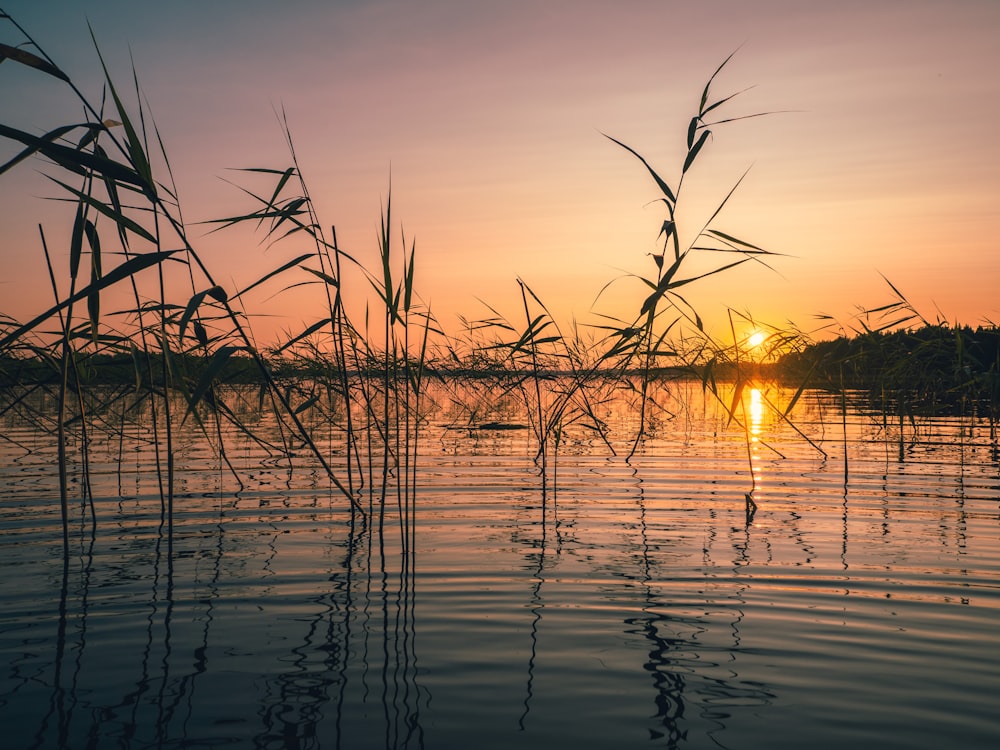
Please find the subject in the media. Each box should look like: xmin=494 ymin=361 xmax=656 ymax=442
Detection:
xmin=0 ymin=11 xmax=376 ymax=548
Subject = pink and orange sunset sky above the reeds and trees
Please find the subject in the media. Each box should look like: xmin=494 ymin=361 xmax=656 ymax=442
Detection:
xmin=0 ymin=0 xmax=1000 ymax=346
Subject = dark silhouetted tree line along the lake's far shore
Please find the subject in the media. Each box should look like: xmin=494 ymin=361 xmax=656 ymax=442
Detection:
xmin=0 ymin=324 xmax=1000 ymax=419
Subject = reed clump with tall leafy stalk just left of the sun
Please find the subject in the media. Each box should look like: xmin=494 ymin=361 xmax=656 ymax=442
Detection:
xmin=453 ymin=55 xmax=798 ymax=513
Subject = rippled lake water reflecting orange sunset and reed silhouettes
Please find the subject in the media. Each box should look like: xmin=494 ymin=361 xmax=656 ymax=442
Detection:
xmin=0 ymin=386 xmax=1000 ymax=750
